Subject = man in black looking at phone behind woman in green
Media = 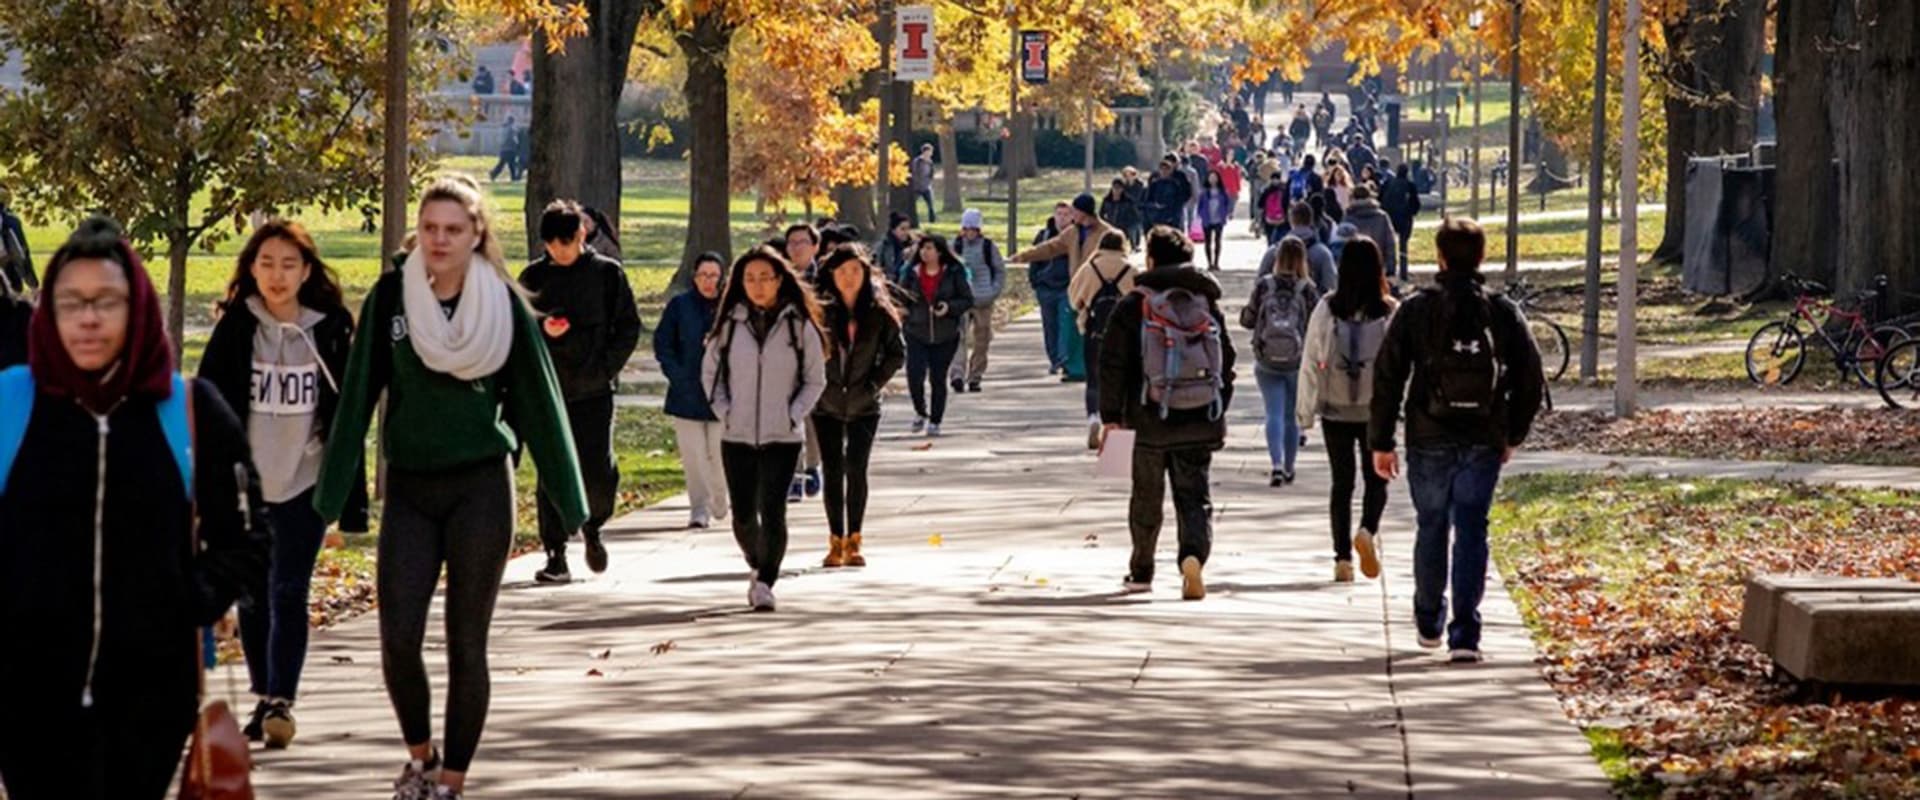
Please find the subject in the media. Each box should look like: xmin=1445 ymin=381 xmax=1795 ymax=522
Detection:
xmin=520 ymin=200 xmax=639 ymax=583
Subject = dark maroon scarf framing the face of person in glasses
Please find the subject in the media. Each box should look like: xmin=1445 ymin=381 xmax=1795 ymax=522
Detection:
xmin=27 ymin=242 xmax=173 ymax=412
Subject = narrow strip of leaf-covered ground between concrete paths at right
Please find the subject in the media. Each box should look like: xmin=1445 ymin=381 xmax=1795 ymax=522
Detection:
xmin=1526 ymin=407 xmax=1920 ymax=466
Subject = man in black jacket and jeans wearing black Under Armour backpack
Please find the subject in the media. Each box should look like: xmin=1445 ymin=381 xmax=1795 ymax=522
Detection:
xmin=1356 ymin=219 xmax=1546 ymax=664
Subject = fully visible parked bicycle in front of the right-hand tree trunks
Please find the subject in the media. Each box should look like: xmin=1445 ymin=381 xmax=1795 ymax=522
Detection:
xmin=1745 ymin=274 xmax=1908 ymax=386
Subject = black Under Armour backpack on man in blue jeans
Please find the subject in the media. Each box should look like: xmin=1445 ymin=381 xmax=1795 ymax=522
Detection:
xmin=1421 ymin=286 xmax=1505 ymax=420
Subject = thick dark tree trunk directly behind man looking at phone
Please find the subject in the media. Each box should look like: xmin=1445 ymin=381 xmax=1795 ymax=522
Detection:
xmin=524 ymin=0 xmax=660 ymax=253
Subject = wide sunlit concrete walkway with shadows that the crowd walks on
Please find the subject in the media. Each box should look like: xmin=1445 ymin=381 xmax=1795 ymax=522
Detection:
xmin=247 ymin=238 xmax=1607 ymax=798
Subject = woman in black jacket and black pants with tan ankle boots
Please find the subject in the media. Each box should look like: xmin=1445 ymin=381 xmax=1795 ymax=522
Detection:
xmin=812 ymin=246 xmax=906 ymax=568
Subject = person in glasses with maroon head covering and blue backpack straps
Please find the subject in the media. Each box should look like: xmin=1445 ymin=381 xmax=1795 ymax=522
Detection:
xmin=0 ymin=217 xmax=267 ymax=800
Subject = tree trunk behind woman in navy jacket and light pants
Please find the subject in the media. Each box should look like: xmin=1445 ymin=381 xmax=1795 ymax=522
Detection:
xmin=672 ymin=12 xmax=733 ymax=290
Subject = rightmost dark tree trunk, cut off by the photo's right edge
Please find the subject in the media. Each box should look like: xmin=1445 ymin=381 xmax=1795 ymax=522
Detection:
xmin=1827 ymin=2 xmax=1920 ymax=305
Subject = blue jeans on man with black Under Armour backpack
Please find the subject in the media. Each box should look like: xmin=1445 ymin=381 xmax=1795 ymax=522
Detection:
xmin=1407 ymin=445 xmax=1500 ymax=648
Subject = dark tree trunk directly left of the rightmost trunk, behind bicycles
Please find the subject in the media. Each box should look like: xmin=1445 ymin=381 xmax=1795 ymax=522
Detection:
xmin=1772 ymin=0 xmax=1839 ymax=282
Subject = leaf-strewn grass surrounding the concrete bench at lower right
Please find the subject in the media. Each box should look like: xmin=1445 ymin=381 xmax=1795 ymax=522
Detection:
xmin=1496 ymin=476 xmax=1920 ymax=798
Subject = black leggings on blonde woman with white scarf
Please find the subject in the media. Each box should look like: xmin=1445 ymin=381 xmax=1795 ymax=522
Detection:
xmin=376 ymin=459 xmax=513 ymax=773
